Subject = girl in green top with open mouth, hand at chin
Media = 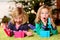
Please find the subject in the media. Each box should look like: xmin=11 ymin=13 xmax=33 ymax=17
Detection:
xmin=35 ymin=5 xmax=58 ymax=35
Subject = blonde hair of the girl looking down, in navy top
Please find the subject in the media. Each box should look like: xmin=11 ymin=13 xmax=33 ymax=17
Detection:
xmin=10 ymin=8 xmax=28 ymax=24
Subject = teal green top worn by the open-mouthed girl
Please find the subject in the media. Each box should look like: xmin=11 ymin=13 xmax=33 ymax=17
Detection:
xmin=35 ymin=18 xmax=58 ymax=34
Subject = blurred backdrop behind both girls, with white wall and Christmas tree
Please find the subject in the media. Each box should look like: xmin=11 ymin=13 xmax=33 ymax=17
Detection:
xmin=0 ymin=0 xmax=60 ymax=25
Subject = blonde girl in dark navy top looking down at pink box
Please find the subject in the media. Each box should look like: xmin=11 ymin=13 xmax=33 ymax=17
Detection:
xmin=3 ymin=4 xmax=32 ymax=36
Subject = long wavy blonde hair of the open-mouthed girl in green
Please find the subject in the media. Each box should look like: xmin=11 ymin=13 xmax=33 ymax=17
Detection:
xmin=35 ymin=5 xmax=55 ymax=27
